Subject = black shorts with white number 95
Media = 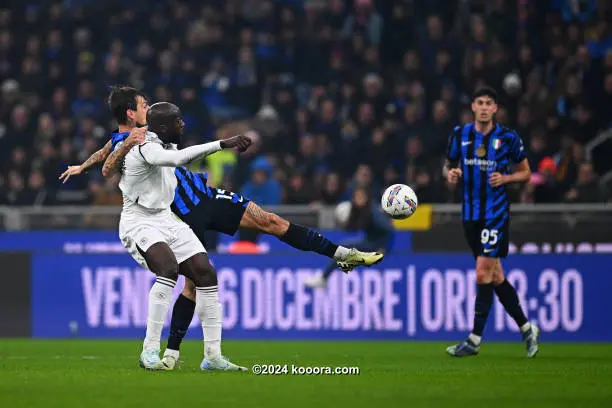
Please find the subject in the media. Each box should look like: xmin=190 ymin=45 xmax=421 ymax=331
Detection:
xmin=463 ymin=215 xmax=510 ymax=258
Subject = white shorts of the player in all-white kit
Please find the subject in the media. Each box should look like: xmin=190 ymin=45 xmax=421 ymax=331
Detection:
xmin=119 ymin=211 xmax=206 ymax=269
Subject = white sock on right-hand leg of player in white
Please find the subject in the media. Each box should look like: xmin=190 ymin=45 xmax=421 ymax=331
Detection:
xmin=196 ymin=285 xmax=223 ymax=358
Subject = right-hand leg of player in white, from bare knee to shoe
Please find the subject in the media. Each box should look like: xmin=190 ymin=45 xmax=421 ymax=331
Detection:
xmin=179 ymin=253 xmax=248 ymax=371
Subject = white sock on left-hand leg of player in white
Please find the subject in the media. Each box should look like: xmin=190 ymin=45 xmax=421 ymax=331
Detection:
xmin=142 ymin=276 xmax=176 ymax=350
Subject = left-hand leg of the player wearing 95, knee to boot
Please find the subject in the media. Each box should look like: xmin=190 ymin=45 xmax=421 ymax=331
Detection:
xmin=446 ymin=257 xmax=496 ymax=357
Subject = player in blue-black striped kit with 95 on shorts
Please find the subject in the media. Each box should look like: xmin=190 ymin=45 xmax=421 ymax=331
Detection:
xmin=444 ymin=88 xmax=540 ymax=358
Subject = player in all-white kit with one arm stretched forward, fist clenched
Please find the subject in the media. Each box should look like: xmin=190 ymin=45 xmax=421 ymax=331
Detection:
xmin=119 ymin=102 xmax=251 ymax=371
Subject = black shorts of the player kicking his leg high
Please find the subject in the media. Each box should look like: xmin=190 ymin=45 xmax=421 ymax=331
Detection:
xmin=177 ymin=187 xmax=250 ymax=241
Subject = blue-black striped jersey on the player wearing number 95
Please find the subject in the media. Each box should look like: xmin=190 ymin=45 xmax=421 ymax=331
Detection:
xmin=446 ymin=123 xmax=526 ymax=221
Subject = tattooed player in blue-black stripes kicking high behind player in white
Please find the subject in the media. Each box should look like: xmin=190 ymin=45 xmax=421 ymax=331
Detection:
xmin=60 ymin=87 xmax=383 ymax=370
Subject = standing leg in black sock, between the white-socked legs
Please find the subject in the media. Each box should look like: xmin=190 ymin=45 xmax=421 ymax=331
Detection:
xmin=162 ymin=278 xmax=195 ymax=370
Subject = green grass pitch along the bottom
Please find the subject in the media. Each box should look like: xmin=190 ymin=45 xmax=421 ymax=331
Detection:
xmin=0 ymin=340 xmax=612 ymax=408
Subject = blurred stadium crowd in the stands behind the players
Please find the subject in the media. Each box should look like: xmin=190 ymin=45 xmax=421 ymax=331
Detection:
xmin=0 ymin=0 xmax=612 ymax=205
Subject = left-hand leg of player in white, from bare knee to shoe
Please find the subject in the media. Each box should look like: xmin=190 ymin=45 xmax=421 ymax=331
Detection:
xmin=140 ymin=242 xmax=178 ymax=370
